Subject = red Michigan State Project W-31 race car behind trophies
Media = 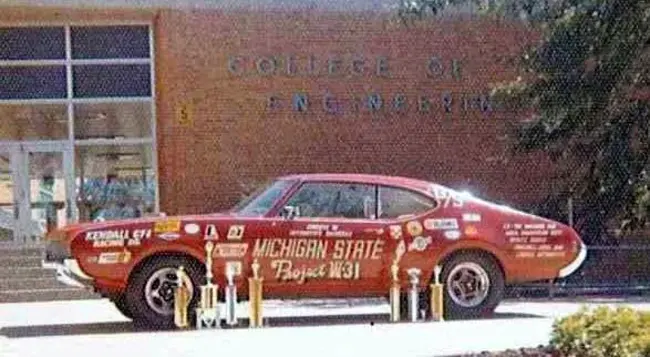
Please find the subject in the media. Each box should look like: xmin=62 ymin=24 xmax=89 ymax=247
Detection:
xmin=45 ymin=174 xmax=586 ymax=327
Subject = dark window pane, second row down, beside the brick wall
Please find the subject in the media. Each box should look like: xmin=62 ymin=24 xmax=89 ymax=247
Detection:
xmin=72 ymin=64 xmax=151 ymax=98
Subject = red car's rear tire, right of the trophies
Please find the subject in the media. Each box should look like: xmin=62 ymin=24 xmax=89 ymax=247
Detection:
xmin=432 ymin=252 xmax=505 ymax=320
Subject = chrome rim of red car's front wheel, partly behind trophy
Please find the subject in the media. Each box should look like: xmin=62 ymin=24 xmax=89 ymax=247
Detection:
xmin=144 ymin=268 xmax=194 ymax=316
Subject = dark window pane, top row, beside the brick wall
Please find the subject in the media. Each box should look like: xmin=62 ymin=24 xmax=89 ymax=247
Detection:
xmin=70 ymin=26 xmax=149 ymax=59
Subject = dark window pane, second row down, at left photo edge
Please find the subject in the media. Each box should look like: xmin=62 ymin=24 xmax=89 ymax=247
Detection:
xmin=0 ymin=66 xmax=66 ymax=99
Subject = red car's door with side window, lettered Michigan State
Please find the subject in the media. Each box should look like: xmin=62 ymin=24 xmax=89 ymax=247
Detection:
xmin=257 ymin=182 xmax=387 ymax=297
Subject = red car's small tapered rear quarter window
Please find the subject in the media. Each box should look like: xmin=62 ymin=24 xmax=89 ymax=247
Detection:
xmin=379 ymin=186 xmax=436 ymax=218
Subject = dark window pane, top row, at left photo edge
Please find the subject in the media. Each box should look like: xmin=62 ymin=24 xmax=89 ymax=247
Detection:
xmin=0 ymin=27 xmax=65 ymax=60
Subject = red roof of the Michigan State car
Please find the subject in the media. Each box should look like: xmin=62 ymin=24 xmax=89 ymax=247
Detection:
xmin=280 ymin=173 xmax=434 ymax=191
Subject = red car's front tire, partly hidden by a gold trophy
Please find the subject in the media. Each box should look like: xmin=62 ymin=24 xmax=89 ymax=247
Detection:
xmin=125 ymin=256 xmax=202 ymax=329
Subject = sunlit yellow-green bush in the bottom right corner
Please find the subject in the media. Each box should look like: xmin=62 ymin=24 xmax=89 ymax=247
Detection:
xmin=551 ymin=307 xmax=650 ymax=357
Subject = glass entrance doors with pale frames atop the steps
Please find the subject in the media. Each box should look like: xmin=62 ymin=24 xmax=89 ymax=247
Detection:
xmin=0 ymin=141 xmax=76 ymax=245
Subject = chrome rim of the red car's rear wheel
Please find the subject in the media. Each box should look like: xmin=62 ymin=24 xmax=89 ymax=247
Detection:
xmin=447 ymin=263 xmax=490 ymax=308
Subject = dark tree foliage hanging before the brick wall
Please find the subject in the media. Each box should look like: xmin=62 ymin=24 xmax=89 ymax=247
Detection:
xmin=400 ymin=0 xmax=650 ymax=239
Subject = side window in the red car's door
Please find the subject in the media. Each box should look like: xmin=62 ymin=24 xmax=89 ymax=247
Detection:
xmin=286 ymin=183 xmax=376 ymax=218
